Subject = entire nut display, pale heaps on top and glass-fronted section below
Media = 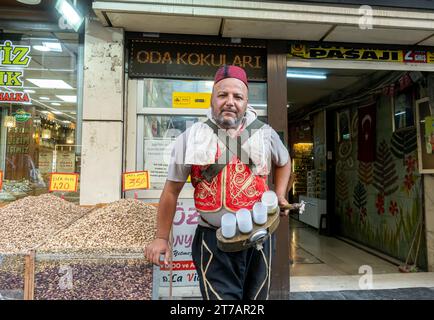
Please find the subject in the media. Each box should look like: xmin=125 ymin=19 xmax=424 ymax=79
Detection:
xmin=0 ymin=194 xmax=156 ymax=299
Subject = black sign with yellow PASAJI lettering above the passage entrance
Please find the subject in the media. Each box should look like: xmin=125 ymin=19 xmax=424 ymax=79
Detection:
xmin=289 ymin=44 xmax=434 ymax=63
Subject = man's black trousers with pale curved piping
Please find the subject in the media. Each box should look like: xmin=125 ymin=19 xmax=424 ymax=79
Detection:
xmin=192 ymin=226 xmax=273 ymax=300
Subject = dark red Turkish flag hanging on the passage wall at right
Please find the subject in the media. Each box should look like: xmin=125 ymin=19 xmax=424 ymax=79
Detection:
xmin=357 ymin=103 xmax=377 ymax=162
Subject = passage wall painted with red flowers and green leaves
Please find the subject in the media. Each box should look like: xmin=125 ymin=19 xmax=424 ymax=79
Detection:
xmin=336 ymin=95 xmax=426 ymax=268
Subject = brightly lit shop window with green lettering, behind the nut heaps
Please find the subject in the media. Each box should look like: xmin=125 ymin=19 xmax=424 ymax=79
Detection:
xmin=0 ymin=31 xmax=80 ymax=202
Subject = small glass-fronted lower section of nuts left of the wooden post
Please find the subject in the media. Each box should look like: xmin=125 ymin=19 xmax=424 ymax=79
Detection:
xmin=0 ymin=253 xmax=26 ymax=300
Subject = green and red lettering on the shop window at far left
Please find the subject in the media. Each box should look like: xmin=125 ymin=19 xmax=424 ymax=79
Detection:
xmin=0 ymin=40 xmax=31 ymax=104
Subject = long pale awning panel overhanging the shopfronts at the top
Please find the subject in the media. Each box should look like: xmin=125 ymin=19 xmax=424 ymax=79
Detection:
xmin=93 ymin=0 xmax=434 ymax=46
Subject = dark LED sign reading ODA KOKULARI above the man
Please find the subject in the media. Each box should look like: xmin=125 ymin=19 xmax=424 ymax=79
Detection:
xmin=128 ymin=39 xmax=267 ymax=81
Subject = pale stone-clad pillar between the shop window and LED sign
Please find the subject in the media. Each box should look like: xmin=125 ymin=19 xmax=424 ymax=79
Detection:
xmin=80 ymin=18 xmax=124 ymax=205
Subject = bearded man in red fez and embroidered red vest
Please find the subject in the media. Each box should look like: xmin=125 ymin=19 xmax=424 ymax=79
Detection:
xmin=145 ymin=65 xmax=291 ymax=300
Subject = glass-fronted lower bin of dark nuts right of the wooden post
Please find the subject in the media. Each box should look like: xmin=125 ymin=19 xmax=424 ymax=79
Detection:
xmin=34 ymin=252 xmax=153 ymax=300
